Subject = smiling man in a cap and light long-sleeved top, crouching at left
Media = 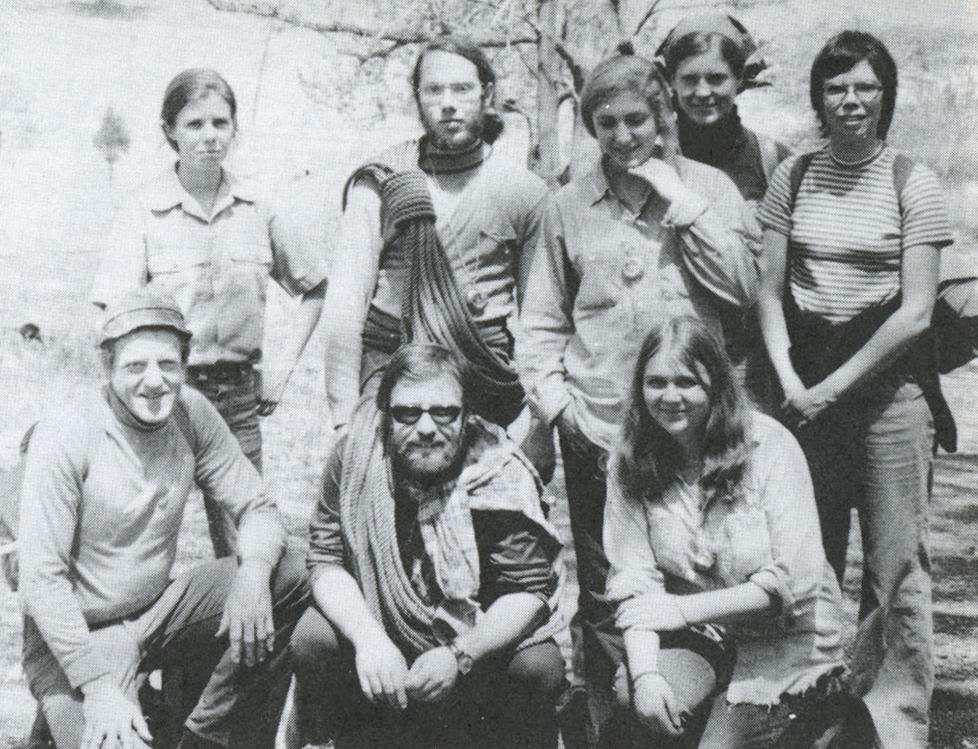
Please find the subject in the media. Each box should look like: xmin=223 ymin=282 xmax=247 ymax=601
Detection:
xmin=19 ymin=289 xmax=307 ymax=749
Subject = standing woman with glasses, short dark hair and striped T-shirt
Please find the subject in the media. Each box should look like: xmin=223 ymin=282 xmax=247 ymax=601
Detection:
xmin=759 ymin=31 xmax=951 ymax=747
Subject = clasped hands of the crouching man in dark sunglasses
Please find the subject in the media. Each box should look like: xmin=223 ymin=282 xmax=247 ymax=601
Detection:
xmin=356 ymin=636 xmax=458 ymax=710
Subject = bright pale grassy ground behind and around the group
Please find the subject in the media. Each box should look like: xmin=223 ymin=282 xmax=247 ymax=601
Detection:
xmin=0 ymin=0 xmax=978 ymax=749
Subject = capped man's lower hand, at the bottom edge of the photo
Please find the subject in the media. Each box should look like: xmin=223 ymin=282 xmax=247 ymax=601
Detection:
xmin=80 ymin=676 xmax=153 ymax=749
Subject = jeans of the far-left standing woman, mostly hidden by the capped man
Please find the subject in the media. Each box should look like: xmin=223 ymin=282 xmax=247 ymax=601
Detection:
xmin=189 ymin=370 xmax=262 ymax=558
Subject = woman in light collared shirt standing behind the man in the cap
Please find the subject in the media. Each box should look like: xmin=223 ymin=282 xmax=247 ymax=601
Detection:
xmin=91 ymin=68 xmax=326 ymax=556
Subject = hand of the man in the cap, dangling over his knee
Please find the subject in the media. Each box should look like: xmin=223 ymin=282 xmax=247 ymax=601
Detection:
xmin=214 ymin=559 xmax=275 ymax=668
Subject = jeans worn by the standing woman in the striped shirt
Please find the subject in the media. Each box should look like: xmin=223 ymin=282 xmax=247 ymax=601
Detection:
xmin=796 ymin=375 xmax=934 ymax=749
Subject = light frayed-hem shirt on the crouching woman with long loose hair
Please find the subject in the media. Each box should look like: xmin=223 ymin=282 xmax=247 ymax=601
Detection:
xmin=604 ymin=413 xmax=843 ymax=705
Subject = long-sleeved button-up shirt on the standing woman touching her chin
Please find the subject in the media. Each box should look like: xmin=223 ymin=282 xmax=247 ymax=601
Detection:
xmin=516 ymin=157 xmax=758 ymax=449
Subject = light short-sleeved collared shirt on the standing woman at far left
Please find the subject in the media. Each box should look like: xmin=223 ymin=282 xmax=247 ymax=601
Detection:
xmin=91 ymin=169 xmax=326 ymax=366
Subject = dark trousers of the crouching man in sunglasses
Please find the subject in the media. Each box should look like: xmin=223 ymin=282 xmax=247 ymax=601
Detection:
xmin=291 ymin=607 xmax=564 ymax=749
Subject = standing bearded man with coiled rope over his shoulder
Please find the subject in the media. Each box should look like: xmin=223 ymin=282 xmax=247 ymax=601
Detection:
xmin=323 ymin=37 xmax=552 ymax=473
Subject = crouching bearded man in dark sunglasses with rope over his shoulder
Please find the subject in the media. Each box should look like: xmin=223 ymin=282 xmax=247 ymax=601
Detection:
xmin=292 ymin=343 xmax=564 ymax=749
